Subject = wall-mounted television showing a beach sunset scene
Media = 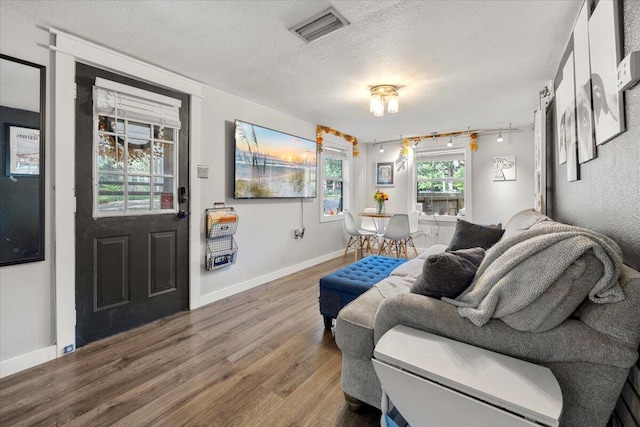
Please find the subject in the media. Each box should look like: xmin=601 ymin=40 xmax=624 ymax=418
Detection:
xmin=233 ymin=120 xmax=317 ymax=199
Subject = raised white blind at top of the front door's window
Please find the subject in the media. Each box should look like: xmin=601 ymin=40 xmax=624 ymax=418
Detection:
xmin=93 ymin=77 xmax=182 ymax=129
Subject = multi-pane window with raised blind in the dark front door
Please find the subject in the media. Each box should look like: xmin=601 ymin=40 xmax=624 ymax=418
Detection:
xmin=93 ymin=78 xmax=181 ymax=217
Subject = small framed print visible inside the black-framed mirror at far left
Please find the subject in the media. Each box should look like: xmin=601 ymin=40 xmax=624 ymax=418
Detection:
xmin=7 ymin=125 xmax=40 ymax=176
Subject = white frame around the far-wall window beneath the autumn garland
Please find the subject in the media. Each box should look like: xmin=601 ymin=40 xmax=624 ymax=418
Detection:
xmin=410 ymin=137 xmax=473 ymax=222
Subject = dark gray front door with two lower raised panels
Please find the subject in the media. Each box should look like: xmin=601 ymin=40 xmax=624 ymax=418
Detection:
xmin=74 ymin=64 xmax=189 ymax=347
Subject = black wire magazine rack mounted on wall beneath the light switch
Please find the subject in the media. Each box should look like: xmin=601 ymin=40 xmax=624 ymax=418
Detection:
xmin=204 ymin=203 xmax=238 ymax=271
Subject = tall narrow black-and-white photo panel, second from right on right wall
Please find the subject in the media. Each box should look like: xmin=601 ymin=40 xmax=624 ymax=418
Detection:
xmin=573 ymin=2 xmax=596 ymax=163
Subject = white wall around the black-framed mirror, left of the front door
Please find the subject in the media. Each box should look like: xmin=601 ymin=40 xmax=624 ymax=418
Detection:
xmin=0 ymin=7 xmax=55 ymax=376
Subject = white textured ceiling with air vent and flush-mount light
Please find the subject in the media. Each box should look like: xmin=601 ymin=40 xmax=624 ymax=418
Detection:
xmin=0 ymin=0 xmax=582 ymax=142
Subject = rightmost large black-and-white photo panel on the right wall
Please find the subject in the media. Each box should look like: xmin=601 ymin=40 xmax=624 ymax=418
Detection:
xmin=589 ymin=0 xmax=625 ymax=145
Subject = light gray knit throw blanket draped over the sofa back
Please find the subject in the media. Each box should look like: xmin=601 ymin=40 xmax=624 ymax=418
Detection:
xmin=442 ymin=223 xmax=624 ymax=326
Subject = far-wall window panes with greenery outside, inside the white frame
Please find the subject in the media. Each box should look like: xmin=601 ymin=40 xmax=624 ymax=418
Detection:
xmin=416 ymin=150 xmax=466 ymax=215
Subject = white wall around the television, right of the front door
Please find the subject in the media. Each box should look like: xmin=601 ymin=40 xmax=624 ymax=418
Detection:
xmin=192 ymin=88 xmax=346 ymax=304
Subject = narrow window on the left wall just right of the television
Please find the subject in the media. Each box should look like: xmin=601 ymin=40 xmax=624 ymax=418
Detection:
xmin=320 ymin=142 xmax=351 ymax=221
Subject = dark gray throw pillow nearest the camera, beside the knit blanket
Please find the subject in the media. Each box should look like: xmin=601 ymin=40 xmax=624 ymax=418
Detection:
xmin=411 ymin=248 xmax=484 ymax=299
